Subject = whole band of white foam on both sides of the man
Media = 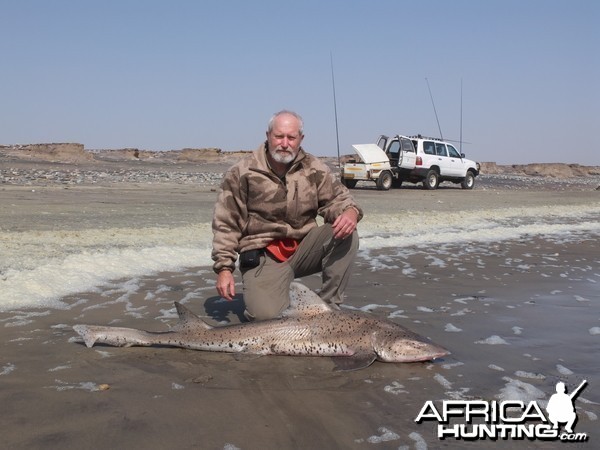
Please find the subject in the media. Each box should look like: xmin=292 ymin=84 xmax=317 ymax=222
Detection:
xmin=0 ymin=205 xmax=600 ymax=312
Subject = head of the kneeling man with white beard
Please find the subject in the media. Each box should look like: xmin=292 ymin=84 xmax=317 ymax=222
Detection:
xmin=267 ymin=114 xmax=304 ymax=164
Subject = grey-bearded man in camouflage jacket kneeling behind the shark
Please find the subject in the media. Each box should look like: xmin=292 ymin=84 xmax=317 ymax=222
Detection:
xmin=212 ymin=111 xmax=362 ymax=320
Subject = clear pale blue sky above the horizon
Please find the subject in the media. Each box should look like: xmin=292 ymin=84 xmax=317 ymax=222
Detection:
xmin=0 ymin=0 xmax=600 ymax=165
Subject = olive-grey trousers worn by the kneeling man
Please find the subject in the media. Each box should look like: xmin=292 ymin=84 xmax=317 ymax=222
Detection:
xmin=242 ymin=224 xmax=358 ymax=320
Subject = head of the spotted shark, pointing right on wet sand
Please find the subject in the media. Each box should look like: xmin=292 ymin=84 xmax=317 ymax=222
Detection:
xmin=373 ymin=331 xmax=450 ymax=362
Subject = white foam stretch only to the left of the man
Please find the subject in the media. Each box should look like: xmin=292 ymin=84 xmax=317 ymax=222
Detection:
xmin=0 ymin=224 xmax=212 ymax=310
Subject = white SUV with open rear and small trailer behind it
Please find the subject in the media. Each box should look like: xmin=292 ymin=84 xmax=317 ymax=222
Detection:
xmin=341 ymin=135 xmax=480 ymax=190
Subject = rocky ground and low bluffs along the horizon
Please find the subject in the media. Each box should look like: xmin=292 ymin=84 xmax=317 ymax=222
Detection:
xmin=0 ymin=144 xmax=600 ymax=190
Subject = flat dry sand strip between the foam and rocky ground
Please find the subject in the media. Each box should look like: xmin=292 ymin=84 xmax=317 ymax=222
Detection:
xmin=0 ymin=177 xmax=600 ymax=231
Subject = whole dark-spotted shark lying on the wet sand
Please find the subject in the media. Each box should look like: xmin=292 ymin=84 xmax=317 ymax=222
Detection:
xmin=73 ymin=282 xmax=450 ymax=371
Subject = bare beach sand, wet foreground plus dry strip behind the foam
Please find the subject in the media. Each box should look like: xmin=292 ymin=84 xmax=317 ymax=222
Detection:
xmin=0 ymin=163 xmax=600 ymax=449
